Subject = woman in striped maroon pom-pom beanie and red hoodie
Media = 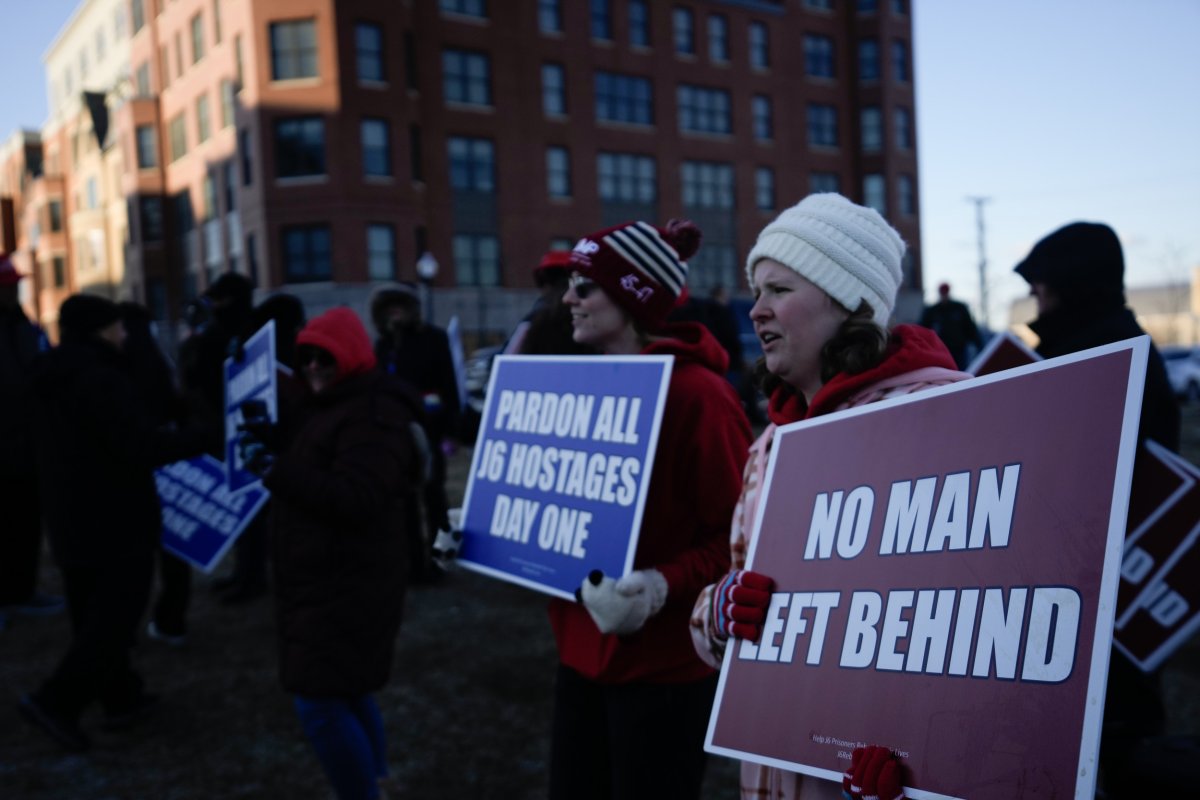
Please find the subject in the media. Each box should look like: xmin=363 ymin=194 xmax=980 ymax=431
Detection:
xmin=550 ymin=222 xmax=750 ymax=800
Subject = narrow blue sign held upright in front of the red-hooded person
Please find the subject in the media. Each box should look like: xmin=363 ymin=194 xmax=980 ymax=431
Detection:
xmin=224 ymin=320 xmax=280 ymax=492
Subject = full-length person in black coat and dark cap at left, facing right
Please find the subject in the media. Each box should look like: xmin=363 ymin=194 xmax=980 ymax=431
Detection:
xmin=19 ymin=295 xmax=203 ymax=751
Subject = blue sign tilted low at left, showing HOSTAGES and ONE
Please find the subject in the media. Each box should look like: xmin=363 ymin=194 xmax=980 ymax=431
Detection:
xmin=155 ymin=455 xmax=270 ymax=572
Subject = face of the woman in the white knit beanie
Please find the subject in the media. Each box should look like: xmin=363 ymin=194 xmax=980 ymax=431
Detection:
xmin=750 ymin=258 xmax=850 ymax=401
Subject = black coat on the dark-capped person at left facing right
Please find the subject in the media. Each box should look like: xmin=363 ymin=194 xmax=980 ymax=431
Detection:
xmin=32 ymin=338 xmax=203 ymax=566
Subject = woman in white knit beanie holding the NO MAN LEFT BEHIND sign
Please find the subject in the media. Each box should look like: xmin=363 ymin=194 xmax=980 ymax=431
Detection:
xmin=690 ymin=194 xmax=971 ymax=800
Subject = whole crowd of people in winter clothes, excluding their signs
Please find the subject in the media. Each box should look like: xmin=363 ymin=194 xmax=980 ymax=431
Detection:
xmin=0 ymin=193 xmax=1180 ymax=800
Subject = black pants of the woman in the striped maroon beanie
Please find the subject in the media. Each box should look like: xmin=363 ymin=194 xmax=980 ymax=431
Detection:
xmin=550 ymin=664 xmax=716 ymax=800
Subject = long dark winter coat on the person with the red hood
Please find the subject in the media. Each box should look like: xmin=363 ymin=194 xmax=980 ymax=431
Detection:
xmin=264 ymin=309 xmax=418 ymax=697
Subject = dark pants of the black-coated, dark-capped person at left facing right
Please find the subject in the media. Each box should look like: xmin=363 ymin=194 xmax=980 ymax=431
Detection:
xmin=35 ymin=549 xmax=154 ymax=721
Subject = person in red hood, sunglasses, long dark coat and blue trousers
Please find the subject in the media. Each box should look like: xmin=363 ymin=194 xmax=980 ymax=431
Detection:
xmin=239 ymin=307 xmax=421 ymax=799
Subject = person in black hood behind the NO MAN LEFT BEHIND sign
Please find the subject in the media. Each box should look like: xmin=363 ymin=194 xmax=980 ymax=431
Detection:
xmin=1014 ymin=222 xmax=1181 ymax=796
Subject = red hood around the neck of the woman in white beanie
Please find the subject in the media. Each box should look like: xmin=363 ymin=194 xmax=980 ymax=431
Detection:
xmin=767 ymin=325 xmax=958 ymax=425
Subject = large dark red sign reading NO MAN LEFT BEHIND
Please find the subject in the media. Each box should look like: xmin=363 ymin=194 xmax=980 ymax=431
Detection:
xmin=707 ymin=337 xmax=1147 ymax=800
